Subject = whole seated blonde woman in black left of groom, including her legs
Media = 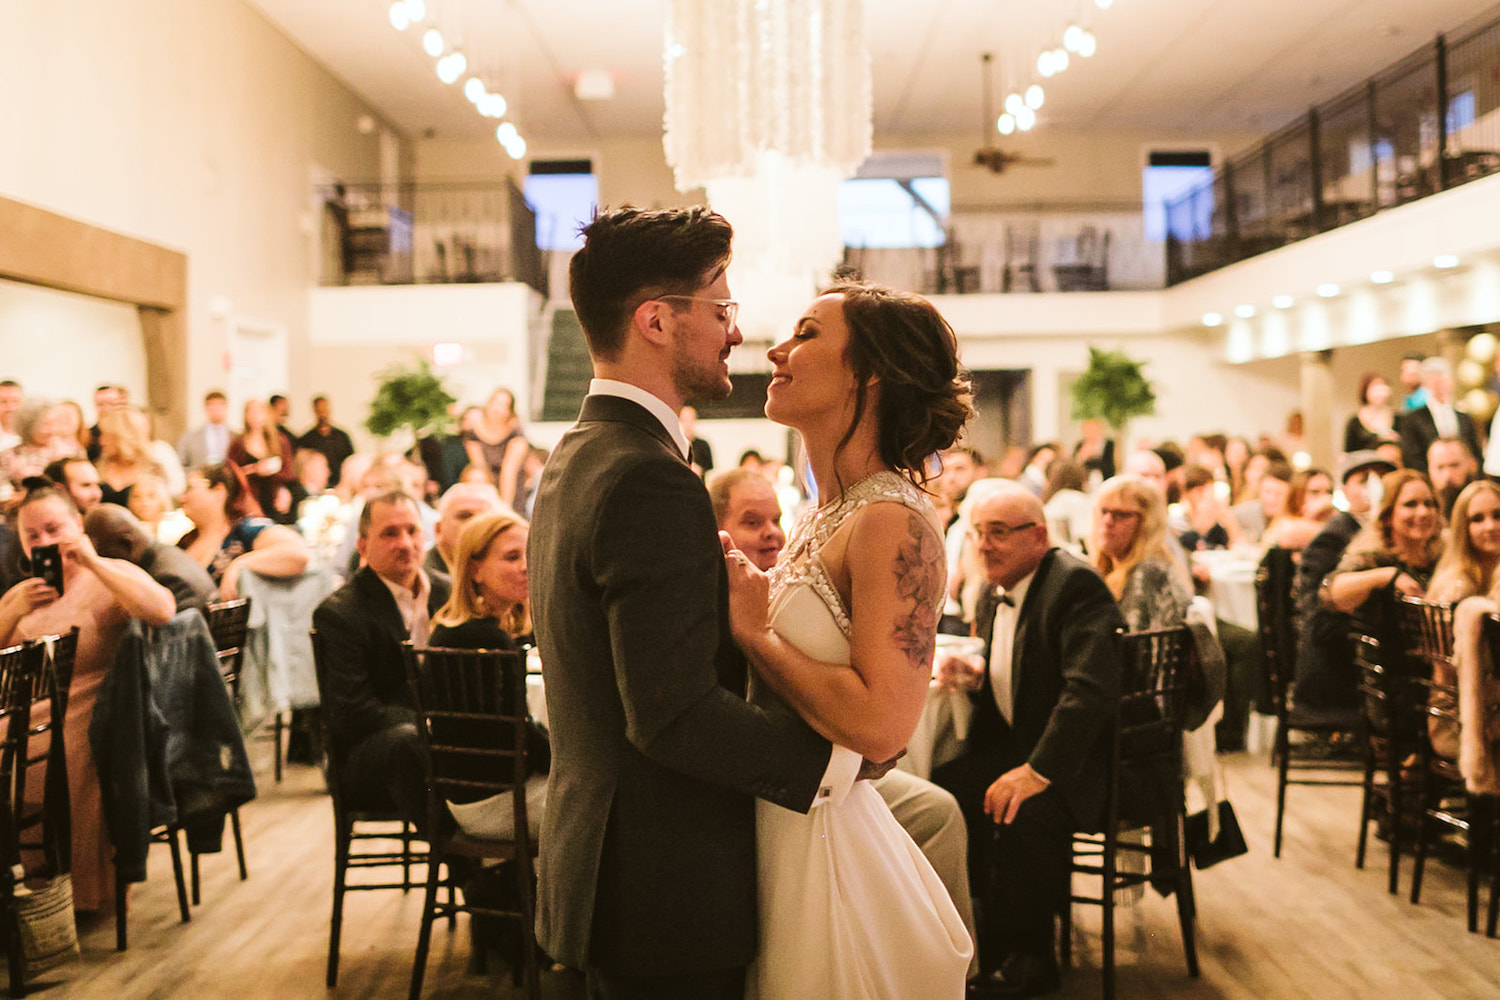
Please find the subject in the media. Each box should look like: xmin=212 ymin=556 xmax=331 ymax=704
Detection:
xmin=428 ymin=512 xmax=551 ymax=838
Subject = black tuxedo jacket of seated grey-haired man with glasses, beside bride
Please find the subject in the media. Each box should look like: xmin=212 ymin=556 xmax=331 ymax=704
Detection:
xmin=966 ymin=549 xmax=1125 ymax=829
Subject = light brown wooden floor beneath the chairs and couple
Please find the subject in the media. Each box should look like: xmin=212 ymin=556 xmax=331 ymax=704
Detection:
xmin=35 ymin=754 xmax=1500 ymax=1000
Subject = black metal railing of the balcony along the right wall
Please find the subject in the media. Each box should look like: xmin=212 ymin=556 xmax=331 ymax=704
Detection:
xmin=1167 ymin=12 xmax=1500 ymax=285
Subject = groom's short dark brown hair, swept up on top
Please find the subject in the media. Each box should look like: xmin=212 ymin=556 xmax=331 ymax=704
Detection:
xmin=569 ymin=205 xmax=735 ymax=360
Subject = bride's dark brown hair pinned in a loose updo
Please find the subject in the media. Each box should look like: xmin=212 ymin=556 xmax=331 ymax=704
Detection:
xmin=824 ymin=282 xmax=974 ymax=486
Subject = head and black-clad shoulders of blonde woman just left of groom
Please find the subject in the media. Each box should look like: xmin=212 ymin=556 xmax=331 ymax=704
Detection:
xmin=431 ymin=510 xmax=531 ymax=649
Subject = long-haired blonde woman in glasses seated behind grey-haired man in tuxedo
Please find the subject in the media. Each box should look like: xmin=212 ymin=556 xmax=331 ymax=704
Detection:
xmin=1094 ymin=475 xmax=1193 ymax=631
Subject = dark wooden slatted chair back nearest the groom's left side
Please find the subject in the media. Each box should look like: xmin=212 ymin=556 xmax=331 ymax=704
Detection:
xmin=404 ymin=643 xmax=528 ymax=843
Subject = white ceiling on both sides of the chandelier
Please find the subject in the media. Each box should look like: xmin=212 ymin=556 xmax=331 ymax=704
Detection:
xmin=249 ymin=0 xmax=1494 ymax=145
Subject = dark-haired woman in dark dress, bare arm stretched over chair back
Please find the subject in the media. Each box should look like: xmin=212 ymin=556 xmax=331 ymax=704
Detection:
xmin=177 ymin=463 xmax=308 ymax=601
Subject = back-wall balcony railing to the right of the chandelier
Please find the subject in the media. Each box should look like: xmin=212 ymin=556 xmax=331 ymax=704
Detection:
xmin=845 ymin=202 xmax=1166 ymax=295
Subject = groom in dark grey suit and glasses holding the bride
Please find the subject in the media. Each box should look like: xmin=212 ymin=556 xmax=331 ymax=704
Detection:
xmin=528 ymin=207 xmax=861 ymax=1000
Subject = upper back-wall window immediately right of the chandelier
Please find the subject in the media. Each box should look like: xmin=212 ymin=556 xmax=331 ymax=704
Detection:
xmin=839 ymin=153 xmax=950 ymax=247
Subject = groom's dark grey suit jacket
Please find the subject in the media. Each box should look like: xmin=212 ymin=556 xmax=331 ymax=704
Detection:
xmin=528 ymin=396 xmax=830 ymax=976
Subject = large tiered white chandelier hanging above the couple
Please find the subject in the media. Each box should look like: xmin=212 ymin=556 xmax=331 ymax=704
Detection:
xmin=663 ymin=0 xmax=872 ymax=347
